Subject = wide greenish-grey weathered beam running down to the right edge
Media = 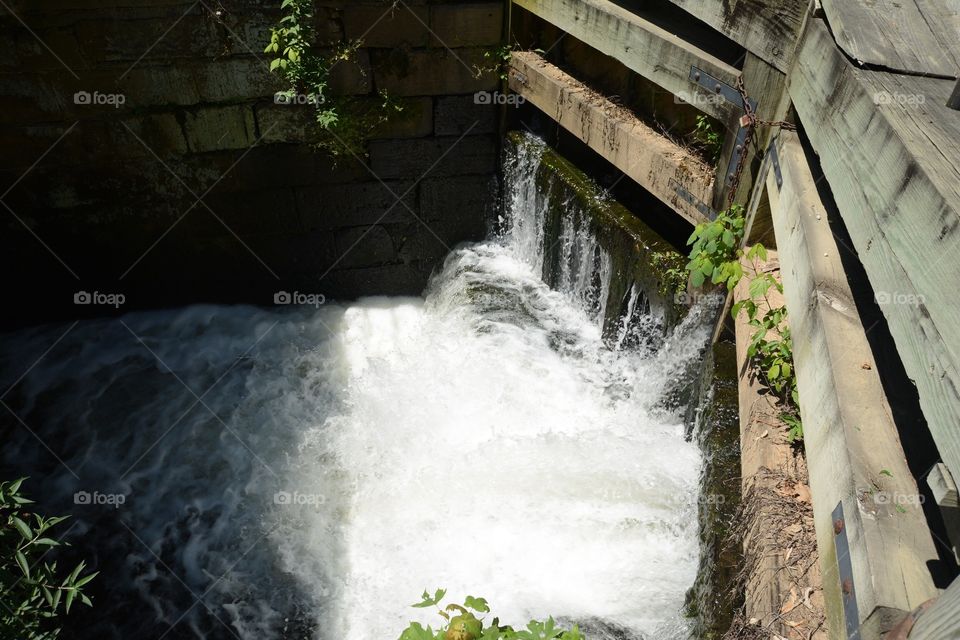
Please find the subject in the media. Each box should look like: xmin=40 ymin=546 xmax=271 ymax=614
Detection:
xmin=789 ymin=20 xmax=960 ymax=502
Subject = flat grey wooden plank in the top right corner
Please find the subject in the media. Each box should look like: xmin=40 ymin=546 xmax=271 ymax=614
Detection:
xmin=822 ymin=0 xmax=960 ymax=78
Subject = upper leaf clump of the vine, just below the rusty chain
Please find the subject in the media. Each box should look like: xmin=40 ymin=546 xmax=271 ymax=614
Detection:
xmin=687 ymin=205 xmax=744 ymax=290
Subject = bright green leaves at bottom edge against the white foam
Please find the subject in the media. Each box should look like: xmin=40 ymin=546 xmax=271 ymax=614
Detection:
xmin=399 ymin=589 xmax=586 ymax=640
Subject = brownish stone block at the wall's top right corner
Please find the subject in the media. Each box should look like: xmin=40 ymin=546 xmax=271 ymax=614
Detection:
xmin=430 ymin=2 xmax=504 ymax=48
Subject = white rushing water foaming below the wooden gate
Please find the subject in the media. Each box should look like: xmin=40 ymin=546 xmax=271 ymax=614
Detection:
xmin=0 ymin=132 xmax=707 ymax=640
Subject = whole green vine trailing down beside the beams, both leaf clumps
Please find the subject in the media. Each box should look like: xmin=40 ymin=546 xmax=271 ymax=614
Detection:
xmin=687 ymin=205 xmax=803 ymax=442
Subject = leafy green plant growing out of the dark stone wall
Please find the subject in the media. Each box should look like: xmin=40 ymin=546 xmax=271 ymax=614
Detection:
xmin=264 ymin=0 xmax=403 ymax=158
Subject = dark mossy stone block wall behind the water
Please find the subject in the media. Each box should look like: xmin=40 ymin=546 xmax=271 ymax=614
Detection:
xmin=0 ymin=0 xmax=503 ymax=326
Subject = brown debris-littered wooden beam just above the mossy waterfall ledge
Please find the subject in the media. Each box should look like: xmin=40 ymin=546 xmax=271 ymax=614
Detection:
xmin=509 ymin=52 xmax=713 ymax=224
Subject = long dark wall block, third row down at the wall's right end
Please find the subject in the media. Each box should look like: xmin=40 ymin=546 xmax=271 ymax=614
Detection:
xmin=370 ymin=136 xmax=497 ymax=180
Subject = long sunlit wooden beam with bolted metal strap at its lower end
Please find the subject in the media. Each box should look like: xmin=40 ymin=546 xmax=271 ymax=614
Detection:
xmin=766 ymin=132 xmax=937 ymax=640
